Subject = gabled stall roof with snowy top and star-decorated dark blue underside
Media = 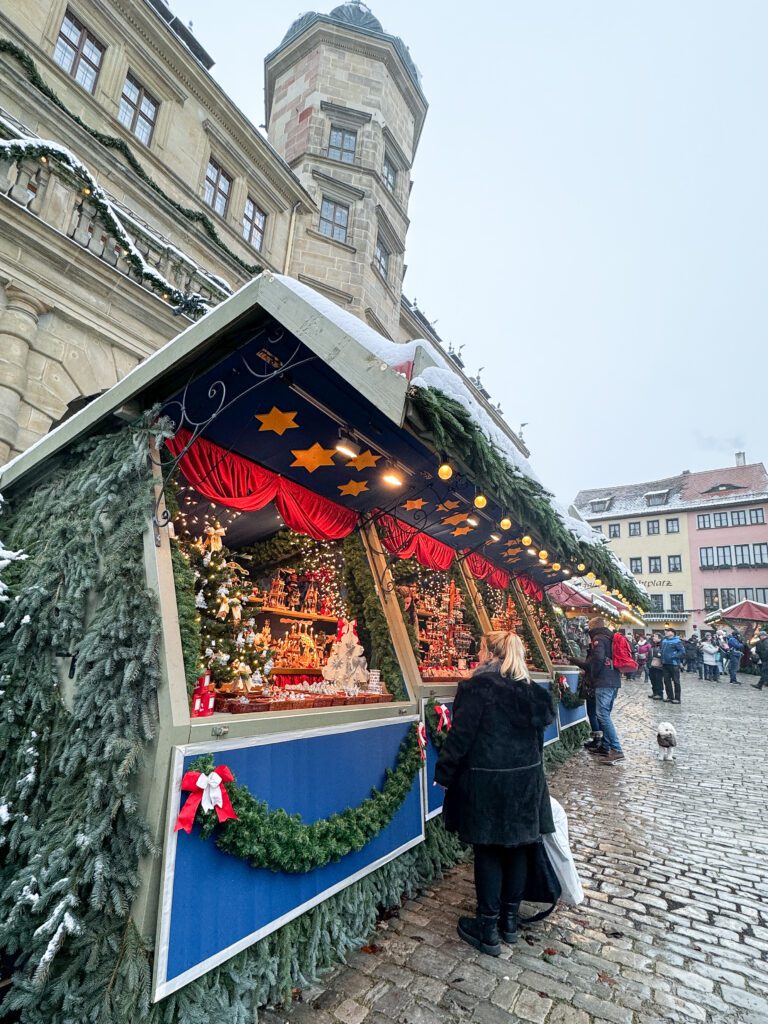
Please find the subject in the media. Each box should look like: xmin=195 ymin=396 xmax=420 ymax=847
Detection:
xmin=0 ymin=271 xmax=647 ymax=598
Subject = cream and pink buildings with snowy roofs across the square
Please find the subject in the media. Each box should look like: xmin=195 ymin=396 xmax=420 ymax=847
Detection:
xmin=574 ymin=453 xmax=768 ymax=634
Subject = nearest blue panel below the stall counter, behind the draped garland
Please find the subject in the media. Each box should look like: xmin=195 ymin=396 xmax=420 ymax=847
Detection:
xmin=167 ymin=722 xmax=423 ymax=981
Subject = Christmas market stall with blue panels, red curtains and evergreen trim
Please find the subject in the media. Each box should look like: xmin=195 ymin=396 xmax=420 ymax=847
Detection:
xmin=0 ymin=273 xmax=651 ymax=1024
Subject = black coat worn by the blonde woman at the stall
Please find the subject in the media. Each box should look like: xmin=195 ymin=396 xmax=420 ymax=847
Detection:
xmin=435 ymin=663 xmax=556 ymax=846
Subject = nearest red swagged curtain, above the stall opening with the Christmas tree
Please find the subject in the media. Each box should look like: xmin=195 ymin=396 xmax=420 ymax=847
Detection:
xmin=166 ymin=430 xmax=357 ymax=541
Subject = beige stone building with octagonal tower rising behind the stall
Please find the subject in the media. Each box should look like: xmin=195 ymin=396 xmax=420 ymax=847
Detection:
xmin=0 ymin=0 xmax=527 ymax=465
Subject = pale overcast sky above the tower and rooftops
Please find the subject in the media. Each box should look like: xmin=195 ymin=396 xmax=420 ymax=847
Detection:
xmin=177 ymin=0 xmax=768 ymax=501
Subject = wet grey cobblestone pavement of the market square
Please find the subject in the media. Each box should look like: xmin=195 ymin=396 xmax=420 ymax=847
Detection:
xmin=260 ymin=676 xmax=768 ymax=1024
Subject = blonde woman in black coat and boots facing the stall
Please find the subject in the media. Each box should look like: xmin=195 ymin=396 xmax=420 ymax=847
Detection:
xmin=434 ymin=631 xmax=556 ymax=956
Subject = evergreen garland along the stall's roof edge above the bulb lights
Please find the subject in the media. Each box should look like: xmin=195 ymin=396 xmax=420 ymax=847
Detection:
xmin=410 ymin=387 xmax=649 ymax=608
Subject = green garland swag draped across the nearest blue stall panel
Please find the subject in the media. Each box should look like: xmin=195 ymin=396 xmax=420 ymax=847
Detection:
xmin=193 ymin=725 xmax=422 ymax=874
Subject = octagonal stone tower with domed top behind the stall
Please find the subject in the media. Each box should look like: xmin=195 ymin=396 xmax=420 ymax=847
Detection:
xmin=265 ymin=2 xmax=427 ymax=339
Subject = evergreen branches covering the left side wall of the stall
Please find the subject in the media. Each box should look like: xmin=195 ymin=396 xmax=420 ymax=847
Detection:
xmin=0 ymin=422 xmax=165 ymax=1024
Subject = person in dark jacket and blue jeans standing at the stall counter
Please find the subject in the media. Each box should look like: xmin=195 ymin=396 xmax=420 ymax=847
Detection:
xmin=577 ymin=615 xmax=624 ymax=764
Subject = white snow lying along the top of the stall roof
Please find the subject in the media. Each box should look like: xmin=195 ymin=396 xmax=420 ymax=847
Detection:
xmin=278 ymin=275 xmax=614 ymax=557
